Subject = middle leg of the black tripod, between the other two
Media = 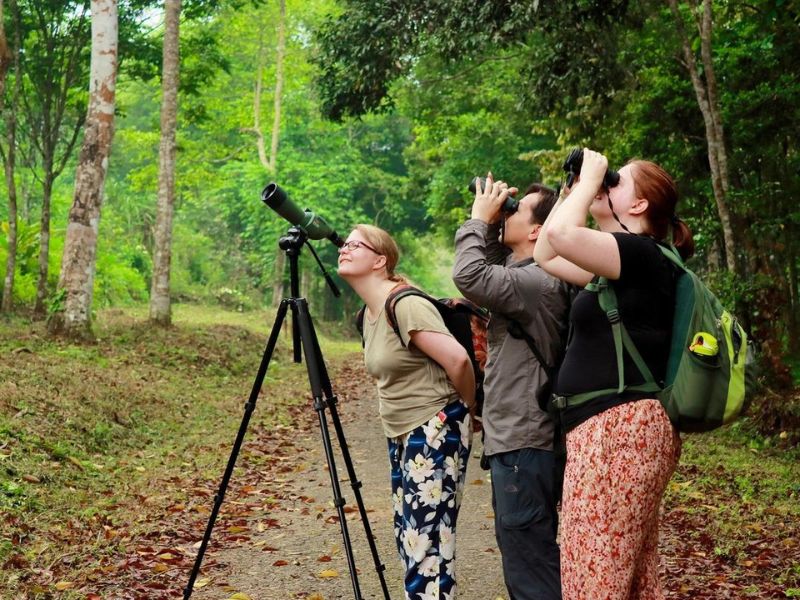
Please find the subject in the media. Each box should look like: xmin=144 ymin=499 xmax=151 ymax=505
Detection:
xmin=293 ymin=298 xmax=363 ymax=600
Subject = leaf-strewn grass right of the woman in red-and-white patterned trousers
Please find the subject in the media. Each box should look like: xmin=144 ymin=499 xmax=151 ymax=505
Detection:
xmin=665 ymin=418 xmax=800 ymax=598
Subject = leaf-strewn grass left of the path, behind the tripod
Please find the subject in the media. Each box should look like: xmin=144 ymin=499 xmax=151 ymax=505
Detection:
xmin=0 ymin=305 xmax=360 ymax=598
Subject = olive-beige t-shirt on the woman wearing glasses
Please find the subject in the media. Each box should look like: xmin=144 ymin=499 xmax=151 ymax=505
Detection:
xmin=364 ymin=296 xmax=458 ymax=438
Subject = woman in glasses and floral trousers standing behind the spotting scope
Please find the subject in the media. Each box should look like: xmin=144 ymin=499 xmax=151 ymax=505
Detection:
xmin=338 ymin=225 xmax=475 ymax=600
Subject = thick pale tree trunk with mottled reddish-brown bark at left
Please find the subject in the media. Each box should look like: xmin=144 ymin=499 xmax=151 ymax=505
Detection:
xmin=48 ymin=0 xmax=118 ymax=338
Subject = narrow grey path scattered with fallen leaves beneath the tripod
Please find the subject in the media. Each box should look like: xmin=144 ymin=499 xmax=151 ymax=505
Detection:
xmin=192 ymin=368 xmax=507 ymax=600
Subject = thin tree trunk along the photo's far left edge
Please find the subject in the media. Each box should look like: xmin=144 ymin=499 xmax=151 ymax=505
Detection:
xmin=0 ymin=0 xmax=20 ymax=313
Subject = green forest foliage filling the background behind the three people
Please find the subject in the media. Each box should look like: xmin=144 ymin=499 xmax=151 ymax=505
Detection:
xmin=0 ymin=0 xmax=800 ymax=412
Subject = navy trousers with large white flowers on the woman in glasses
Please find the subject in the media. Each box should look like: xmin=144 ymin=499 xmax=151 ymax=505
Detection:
xmin=389 ymin=401 xmax=472 ymax=600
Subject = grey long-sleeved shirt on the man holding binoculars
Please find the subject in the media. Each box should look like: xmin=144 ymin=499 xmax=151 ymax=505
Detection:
xmin=453 ymin=219 xmax=569 ymax=456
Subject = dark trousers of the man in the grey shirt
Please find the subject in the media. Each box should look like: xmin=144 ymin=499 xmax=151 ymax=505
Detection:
xmin=489 ymin=448 xmax=561 ymax=600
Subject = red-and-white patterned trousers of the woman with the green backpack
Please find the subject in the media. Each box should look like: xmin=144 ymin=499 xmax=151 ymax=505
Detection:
xmin=561 ymin=400 xmax=681 ymax=600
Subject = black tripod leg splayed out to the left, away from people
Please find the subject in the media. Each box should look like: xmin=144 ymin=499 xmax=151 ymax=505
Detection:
xmin=183 ymin=299 xmax=289 ymax=600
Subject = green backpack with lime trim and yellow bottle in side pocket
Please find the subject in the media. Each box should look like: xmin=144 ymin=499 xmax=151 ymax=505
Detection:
xmin=553 ymin=244 xmax=754 ymax=432
